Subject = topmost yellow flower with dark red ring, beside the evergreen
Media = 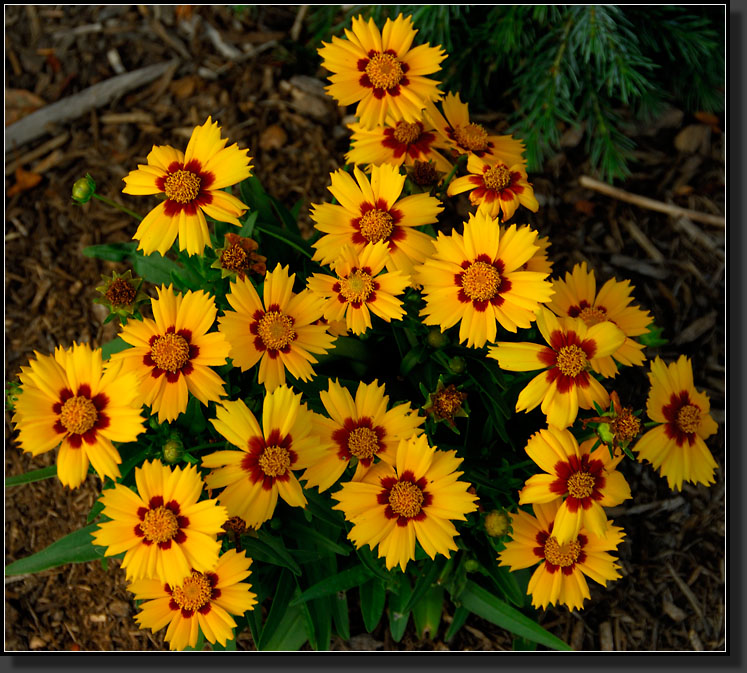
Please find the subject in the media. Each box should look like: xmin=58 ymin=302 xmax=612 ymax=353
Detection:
xmin=318 ymin=14 xmax=446 ymax=128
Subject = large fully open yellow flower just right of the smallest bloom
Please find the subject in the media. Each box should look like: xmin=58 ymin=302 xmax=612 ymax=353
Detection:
xmin=415 ymin=213 xmax=552 ymax=348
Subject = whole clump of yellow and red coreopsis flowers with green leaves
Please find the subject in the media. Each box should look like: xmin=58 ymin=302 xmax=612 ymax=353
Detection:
xmin=6 ymin=11 xmax=716 ymax=650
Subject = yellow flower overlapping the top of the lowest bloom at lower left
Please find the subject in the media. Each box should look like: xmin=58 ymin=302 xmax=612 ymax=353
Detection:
xmin=93 ymin=460 xmax=228 ymax=586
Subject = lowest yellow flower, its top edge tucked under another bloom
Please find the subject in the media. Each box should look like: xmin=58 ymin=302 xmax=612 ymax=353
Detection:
xmin=128 ymin=549 xmax=257 ymax=650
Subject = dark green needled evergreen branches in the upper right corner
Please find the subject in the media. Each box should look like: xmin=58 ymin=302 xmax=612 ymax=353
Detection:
xmin=310 ymin=5 xmax=725 ymax=181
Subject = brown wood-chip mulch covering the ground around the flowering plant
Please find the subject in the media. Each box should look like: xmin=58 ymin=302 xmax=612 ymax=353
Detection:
xmin=5 ymin=5 xmax=725 ymax=651
